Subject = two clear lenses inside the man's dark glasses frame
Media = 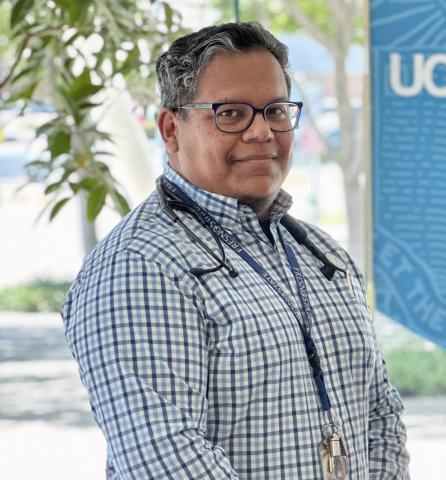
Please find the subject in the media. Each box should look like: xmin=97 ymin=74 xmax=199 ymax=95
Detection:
xmin=215 ymin=102 xmax=300 ymax=133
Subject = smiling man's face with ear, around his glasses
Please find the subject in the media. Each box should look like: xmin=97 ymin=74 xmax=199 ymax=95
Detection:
xmin=159 ymin=50 xmax=293 ymax=204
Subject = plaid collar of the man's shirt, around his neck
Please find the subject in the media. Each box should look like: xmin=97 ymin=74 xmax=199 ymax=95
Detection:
xmin=164 ymin=164 xmax=293 ymax=230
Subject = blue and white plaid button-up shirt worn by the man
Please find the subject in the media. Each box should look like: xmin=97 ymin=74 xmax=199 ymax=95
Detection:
xmin=62 ymin=167 xmax=409 ymax=480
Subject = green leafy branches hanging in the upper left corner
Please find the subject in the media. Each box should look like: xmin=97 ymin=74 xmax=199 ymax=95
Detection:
xmin=0 ymin=0 xmax=185 ymax=221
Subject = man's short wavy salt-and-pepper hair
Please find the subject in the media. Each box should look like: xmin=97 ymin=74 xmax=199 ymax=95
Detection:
xmin=156 ymin=22 xmax=291 ymax=112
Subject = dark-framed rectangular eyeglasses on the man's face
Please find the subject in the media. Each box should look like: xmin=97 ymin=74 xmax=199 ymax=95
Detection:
xmin=178 ymin=102 xmax=303 ymax=133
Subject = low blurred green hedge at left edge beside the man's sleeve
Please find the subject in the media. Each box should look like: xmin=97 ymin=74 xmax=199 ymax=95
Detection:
xmin=0 ymin=280 xmax=70 ymax=312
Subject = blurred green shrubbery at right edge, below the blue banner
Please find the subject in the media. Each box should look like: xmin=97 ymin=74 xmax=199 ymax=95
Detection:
xmin=385 ymin=341 xmax=446 ymax=396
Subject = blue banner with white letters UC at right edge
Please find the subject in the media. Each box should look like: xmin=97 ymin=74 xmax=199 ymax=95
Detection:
xmin=370 ymin=0 xmax=446 ymax=349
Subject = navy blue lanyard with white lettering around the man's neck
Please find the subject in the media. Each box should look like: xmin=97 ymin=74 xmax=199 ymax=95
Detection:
xmin=161 ymin=176 xmax=331 ymax=412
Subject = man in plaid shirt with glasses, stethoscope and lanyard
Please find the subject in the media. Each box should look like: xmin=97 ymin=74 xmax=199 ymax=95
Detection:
xmin=63 ymin=22 xmax=408 ymax=480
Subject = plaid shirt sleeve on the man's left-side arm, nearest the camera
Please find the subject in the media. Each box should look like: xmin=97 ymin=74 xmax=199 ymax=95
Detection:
xmin=62 ymin=251 xmax=238 ymax=480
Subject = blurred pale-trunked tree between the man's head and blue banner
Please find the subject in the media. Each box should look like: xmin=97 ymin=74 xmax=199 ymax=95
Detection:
xmin=215 ymin=0 xmax=366 ymax=267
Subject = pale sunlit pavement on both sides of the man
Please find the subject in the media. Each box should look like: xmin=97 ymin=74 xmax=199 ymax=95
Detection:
xmin=0 ymin=312 xmax=446 ymax=480
